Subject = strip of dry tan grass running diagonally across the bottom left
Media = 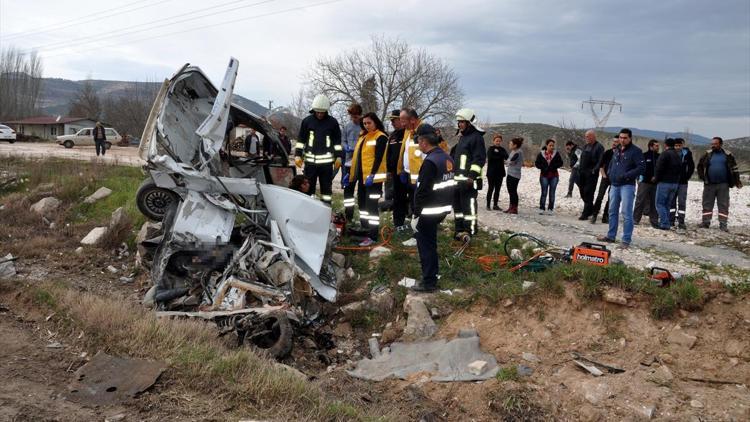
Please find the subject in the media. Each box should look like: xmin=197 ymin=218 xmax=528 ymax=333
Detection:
xmin=7 ymin=283 xmax=390 ymax=421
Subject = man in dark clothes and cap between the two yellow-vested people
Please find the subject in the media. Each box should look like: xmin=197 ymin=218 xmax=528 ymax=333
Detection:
xmin=385 ymin=110 xmax=410 ymax=227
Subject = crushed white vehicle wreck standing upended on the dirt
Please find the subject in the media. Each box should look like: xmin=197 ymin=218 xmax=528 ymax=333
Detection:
xmin=139 ymin=59 xmax=337 ymax=358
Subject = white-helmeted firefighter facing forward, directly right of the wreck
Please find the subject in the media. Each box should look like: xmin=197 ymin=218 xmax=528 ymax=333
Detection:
xmin=294 ymin=94 xmax=343 ymax=205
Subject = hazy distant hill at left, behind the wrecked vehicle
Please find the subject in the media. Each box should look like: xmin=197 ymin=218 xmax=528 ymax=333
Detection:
xmin=39 ymin=78 xmax=268 ymax=116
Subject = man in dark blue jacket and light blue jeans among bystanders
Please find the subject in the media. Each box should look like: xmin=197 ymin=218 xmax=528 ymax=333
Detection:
xmin=597 ymin=128 xmax=646 ymax=249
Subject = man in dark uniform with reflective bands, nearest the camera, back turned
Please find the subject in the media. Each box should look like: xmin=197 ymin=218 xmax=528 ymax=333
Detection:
xmin=411 ymin=132 xmax=456 ymax=292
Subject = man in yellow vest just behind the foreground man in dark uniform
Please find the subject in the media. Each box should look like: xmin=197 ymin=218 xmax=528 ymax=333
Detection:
xmin=393 ymin=108 xmax=435 ymax=231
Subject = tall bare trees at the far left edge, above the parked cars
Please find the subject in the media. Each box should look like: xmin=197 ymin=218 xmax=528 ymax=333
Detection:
xmin=0 ymin=47 xmax=42 ymax=120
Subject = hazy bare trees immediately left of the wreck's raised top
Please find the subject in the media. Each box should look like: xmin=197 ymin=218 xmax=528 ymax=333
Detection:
xmin=102 ymin=82 xmax=159 ymax=141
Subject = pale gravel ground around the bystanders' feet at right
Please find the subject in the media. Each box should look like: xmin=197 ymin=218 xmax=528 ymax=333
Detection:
xmin=478 ymin=168 xmax=750 ymax=282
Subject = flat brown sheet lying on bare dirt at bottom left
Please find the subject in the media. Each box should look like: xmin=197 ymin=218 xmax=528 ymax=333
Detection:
xmin=65 ymin=352 xmax=166 ymax=406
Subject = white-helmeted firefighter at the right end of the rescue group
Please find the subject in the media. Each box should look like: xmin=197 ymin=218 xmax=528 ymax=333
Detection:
xmin=453 ymin=108 xmax=487 ymax=239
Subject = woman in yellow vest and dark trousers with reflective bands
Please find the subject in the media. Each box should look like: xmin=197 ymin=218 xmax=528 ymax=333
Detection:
xmin=351 ymin=112 xmax=388 ymax=246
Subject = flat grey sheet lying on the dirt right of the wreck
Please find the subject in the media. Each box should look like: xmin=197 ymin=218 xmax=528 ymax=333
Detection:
xmin=347 ymin=330 xmax=499 ymax=382
